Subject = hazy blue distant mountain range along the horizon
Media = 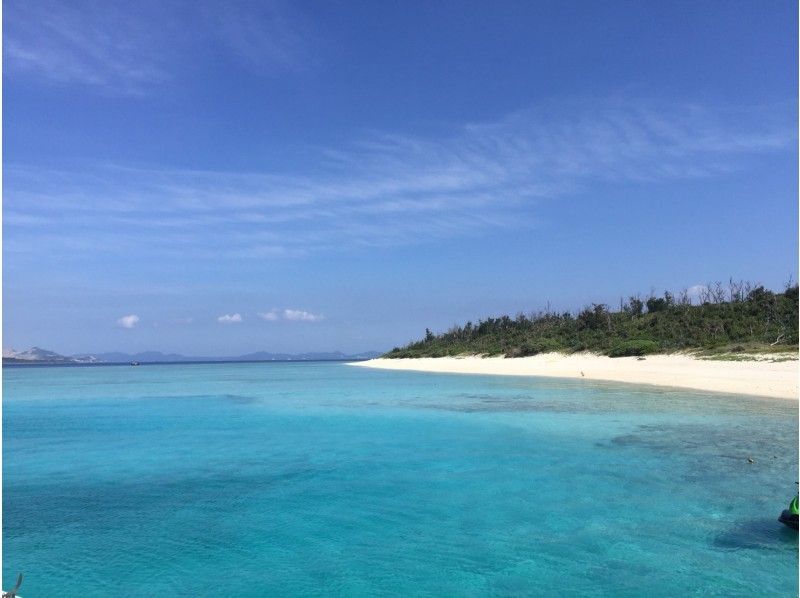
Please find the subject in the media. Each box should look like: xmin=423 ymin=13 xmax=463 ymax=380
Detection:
xmin=3 ymin=347 xmax=381 ymax=364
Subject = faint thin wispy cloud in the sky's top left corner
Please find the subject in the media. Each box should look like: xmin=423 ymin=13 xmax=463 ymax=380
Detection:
xmin=3 ymin=0 xmax=312 ymax=94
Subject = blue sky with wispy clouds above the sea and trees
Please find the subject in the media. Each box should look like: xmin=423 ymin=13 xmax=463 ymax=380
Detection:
xmin=3 ymin=0 xmax=798 ymax=355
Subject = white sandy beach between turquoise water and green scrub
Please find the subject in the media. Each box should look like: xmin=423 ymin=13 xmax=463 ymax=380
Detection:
xmin=351 ymin=353 xmax=798 ymax=400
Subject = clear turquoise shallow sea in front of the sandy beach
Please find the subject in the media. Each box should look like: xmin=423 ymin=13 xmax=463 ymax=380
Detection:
xmin=3 ymin=363 xmax=798 ymax=598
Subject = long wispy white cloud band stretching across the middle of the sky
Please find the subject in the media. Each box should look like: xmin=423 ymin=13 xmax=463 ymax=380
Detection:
xmin=4 ymin=100 xmax=795 ymax=259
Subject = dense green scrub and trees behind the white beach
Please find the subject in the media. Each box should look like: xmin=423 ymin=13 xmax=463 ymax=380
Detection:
xmin=385 ymin=281 xmax=798 ymax=359
